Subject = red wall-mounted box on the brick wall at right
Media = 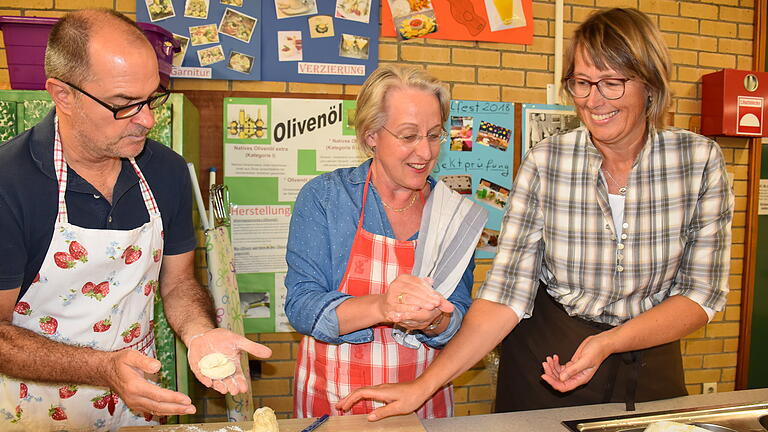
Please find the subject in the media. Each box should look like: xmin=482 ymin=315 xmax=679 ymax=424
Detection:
xmin=701 ymin=69 xmax=768 ymax=137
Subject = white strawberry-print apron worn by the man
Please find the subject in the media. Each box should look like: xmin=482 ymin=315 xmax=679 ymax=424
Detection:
xmin=0 ymin=116 xmax=163 ymax=431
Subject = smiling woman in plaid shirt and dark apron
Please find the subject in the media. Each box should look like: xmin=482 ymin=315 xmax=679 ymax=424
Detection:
xmin=340 ymin=9 xmax=733 ymax=420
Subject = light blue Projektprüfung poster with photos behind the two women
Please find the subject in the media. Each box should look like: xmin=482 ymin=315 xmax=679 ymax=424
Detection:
xmin=432 ymin=100 xmax=515 ymax=258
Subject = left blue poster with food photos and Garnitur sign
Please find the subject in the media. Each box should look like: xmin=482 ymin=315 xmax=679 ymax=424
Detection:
xmin=136 ymin=0 xmax=262 ymax=80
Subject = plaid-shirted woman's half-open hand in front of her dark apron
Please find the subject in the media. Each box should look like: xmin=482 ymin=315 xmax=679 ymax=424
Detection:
xmin=541 ymin=333 xmax=611 ymax=393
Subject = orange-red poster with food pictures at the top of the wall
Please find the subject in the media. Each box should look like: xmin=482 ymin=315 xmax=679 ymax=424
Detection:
xmin=381 ymin=0 xmax=533 ymax=45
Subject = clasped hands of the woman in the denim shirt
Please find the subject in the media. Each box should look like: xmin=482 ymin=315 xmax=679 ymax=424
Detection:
xmin=380 ymin=274 xmax=454 ymax=329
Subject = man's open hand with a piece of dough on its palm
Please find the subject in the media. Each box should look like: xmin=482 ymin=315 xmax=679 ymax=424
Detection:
xmin=187 ymin=328 xmax=272 ymax=395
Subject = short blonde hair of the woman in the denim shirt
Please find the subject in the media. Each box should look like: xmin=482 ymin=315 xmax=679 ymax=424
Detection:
xmin=355 ymin=65 xmax=451 ymax=156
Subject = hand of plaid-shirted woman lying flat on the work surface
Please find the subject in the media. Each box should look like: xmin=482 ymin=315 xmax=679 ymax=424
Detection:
xmin=336 ymin=381 xmax=432 ymax=421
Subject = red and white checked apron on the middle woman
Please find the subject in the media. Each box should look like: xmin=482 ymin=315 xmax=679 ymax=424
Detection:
xmin=293 ymin=171 xmax=453 ymax=418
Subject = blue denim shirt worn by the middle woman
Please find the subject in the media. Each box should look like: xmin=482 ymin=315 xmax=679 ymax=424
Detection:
xmin=285 ymin=160 xmax=475 ymax=348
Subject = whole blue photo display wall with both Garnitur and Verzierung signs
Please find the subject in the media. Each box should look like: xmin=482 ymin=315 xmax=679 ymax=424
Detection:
xmin=136 ymin=0 xmax=380 ymax=84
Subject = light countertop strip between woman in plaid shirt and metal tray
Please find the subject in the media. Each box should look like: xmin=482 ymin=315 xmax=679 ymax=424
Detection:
xmin=422 ymin=388 xmax=768 ymax=432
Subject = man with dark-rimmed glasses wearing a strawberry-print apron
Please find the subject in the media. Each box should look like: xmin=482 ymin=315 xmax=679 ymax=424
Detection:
xmin=0 ymin=9 xmax=270 ymax=431
